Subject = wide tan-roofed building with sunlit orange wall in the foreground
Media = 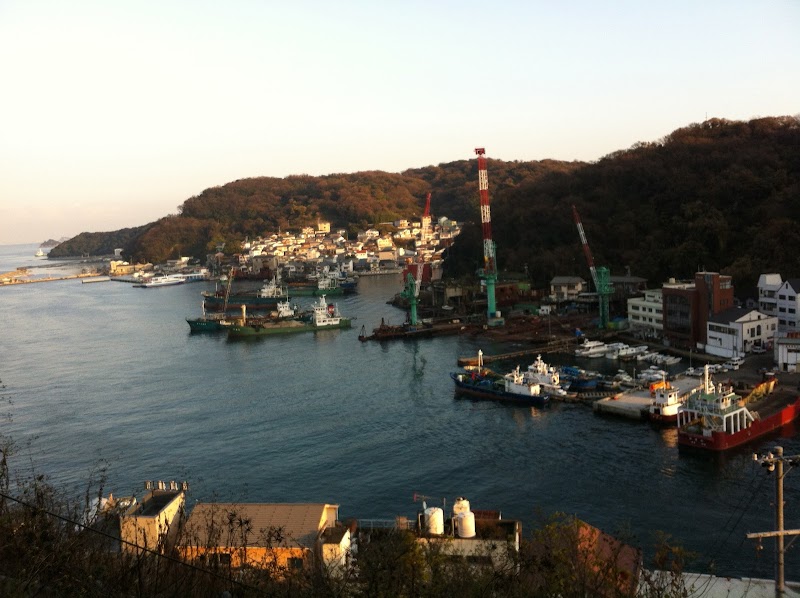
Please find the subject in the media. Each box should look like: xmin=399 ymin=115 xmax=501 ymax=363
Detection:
xmin=178 ymin=503 xmax=350 ymax=572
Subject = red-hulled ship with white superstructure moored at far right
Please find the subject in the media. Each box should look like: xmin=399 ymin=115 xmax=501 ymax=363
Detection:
xmin=678 ymin=366 xmax=800 ymax=451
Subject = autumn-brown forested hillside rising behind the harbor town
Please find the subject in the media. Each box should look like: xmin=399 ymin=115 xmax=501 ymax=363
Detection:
xmin=50 ymin=117 xmax=800 ymax=286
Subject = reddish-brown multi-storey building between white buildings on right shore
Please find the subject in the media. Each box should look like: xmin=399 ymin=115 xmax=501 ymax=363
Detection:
xmin=662 ymin=272 xmax=734 ymax=348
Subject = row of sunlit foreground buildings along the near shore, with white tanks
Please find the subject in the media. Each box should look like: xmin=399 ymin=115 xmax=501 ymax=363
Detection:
xmin=90 ymin=482 xmax=642 ymax=591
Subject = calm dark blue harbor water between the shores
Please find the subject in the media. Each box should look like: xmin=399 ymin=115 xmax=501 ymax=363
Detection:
xmin=0 ymin=245 xmax=800 ymax=579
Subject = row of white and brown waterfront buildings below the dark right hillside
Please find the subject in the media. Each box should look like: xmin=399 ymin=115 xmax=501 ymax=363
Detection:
xmin=550 ymin=271 xmax=800 ymax=372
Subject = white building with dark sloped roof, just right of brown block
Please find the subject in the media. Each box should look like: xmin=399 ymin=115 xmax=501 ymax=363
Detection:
xmin=704 ymin=308 xmax=778 ymax=358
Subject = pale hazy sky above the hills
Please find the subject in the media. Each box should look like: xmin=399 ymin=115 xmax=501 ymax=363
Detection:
xmin=0 ymin=0 xmax=800 ymax=244
